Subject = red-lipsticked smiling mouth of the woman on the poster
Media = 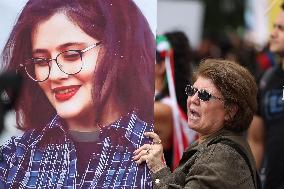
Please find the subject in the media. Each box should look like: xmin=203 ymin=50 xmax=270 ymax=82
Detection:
xmin=52 ymin=85 xmax=80 ymax=101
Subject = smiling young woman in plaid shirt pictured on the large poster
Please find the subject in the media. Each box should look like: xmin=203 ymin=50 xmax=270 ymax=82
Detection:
xmin=0 ymin=0 xmax=156 ymax=188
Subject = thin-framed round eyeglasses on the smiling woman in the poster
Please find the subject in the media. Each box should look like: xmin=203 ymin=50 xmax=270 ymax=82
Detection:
xmin=19 ymin=42 xmax=101 ymax=82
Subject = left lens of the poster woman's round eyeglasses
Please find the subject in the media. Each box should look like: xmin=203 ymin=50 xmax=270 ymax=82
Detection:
xmin=25 ymin=58 xmax=50 ymax=82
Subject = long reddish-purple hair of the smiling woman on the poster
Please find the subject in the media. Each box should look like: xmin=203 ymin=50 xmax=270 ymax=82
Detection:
xmin=2 ymin=0 xmax=155 ymax=128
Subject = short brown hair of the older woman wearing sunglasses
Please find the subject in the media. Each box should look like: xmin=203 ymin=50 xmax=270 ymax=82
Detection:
xmin=193 ymin=59 xmax=257 ymax=132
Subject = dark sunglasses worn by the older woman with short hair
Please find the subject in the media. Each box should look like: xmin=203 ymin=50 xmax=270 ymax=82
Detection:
xmin=185 ymin=85 xmax=223 ymax=102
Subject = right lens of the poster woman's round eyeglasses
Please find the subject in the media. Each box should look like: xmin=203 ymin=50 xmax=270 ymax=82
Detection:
xmin=57 ymin=50 xmax=83 ymax=75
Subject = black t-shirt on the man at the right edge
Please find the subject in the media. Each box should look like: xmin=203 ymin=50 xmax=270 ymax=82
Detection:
xmin=258 ymin=64 xmax=284 ymax=189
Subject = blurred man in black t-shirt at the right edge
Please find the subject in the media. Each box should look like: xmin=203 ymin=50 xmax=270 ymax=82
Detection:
xmin=248 ymin=4 xmax=284 ymax=189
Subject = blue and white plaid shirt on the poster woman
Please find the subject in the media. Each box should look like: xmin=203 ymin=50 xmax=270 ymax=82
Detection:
xmin=0 ymin=113 xmax=153 ymax=189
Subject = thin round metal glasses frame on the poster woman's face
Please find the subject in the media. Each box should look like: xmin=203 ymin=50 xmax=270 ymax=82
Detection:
xmin=16 ymin=41 xmax=101 ymax=82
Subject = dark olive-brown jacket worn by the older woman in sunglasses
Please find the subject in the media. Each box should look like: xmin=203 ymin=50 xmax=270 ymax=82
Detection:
xmin=152 ymin=129 xmax=256 ymax=189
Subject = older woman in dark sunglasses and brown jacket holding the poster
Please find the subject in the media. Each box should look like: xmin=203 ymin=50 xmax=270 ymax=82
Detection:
xmin=134 ymin=59 xmax=258 ymax=189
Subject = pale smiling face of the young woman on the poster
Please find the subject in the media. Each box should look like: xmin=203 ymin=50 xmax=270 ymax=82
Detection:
xmin=32 ymin=13 xmax=100 ymax=123
